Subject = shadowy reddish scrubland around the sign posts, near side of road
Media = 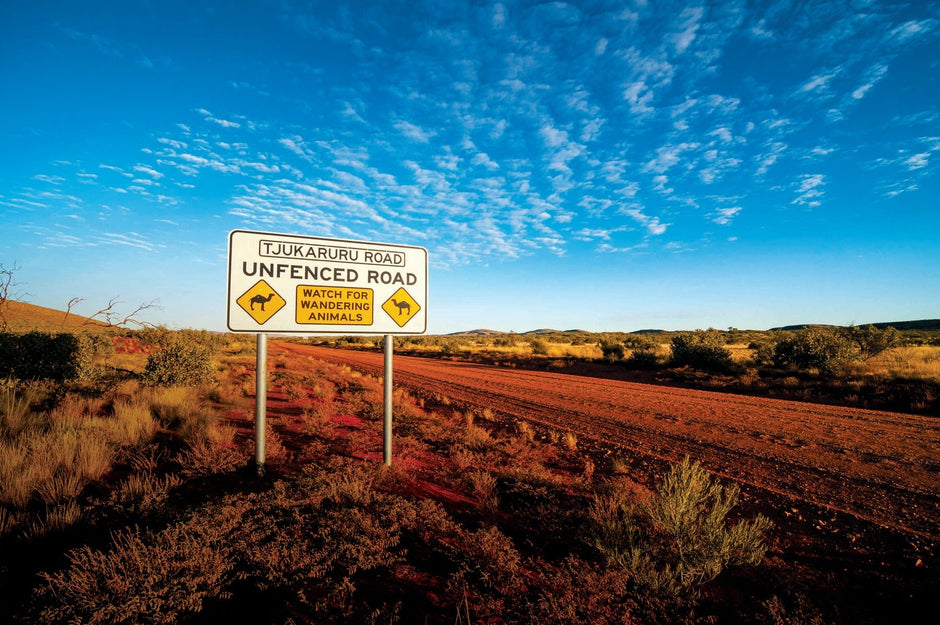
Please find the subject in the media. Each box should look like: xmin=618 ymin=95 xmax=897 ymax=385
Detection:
xmin=0 ymin=330 xmax=800 ymax=623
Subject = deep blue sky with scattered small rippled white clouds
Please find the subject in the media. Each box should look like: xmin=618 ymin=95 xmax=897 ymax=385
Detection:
xmin=0 ymin=0 xmax=940 ymax=333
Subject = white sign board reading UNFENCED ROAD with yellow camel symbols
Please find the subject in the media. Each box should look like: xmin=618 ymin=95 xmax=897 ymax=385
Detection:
xmin=227 ymin=230 xmax=428 ymax=335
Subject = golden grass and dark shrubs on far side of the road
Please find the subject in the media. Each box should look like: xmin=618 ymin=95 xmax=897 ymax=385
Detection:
xmin=322 ymin=325 xmax=940 ymax=414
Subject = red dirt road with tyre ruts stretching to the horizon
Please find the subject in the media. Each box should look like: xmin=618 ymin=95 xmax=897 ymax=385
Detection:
xmin=278 ymin=343 xmax=940 ymax=540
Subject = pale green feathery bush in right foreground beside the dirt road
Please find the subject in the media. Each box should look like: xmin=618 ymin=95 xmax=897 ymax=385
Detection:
xmin=592 ymin=457 xmax=771 ymax=596
